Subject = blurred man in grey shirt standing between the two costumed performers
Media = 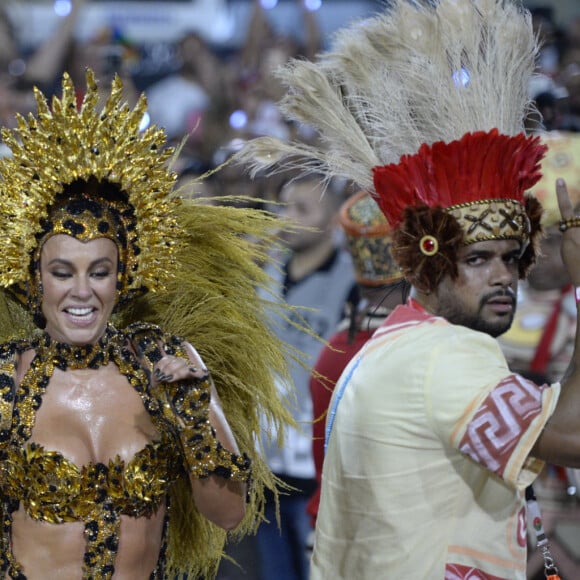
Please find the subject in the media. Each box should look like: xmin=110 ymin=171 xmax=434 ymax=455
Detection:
xmin=256 ymin=174 xmax=355 ymax=580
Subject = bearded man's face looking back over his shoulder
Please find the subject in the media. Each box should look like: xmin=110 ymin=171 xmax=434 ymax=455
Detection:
xmin=435 ymin=240 xmax=520 ymax=337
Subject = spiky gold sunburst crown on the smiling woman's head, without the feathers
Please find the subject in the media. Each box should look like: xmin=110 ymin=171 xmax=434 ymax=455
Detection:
xmin=0 ymin=70 xmax=180 ymax=301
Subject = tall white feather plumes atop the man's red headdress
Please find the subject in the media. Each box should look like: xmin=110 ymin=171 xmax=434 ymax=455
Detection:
xmin=237 ymin=0 xmax=538 ymax=190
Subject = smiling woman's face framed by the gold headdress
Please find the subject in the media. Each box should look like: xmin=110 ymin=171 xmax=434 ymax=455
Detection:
xmin=40 ymin=234 xmax=117 ymax=346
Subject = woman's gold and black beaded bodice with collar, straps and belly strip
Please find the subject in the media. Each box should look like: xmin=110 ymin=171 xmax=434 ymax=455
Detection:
xmin=0 ymin=325 xmax=182 ymax=580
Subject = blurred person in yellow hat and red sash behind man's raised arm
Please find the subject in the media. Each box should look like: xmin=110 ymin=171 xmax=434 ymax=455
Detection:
xmin=498 ymin=132 xmax=580 ymax=579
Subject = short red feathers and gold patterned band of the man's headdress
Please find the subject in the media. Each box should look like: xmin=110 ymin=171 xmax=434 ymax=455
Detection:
xmin=373 ymin=129 xmax=546 ymax=244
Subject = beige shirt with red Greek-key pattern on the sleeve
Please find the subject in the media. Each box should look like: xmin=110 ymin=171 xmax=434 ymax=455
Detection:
xmin=311 ymin=301 xmax=560 ymax=580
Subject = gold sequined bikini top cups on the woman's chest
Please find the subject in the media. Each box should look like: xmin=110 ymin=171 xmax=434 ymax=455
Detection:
xmin=0 ymin=441 xmax=180 ymax=524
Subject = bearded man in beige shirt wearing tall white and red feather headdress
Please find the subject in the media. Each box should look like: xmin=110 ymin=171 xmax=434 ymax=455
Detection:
xmin=233 ymin=0 xmax=580 ymax=580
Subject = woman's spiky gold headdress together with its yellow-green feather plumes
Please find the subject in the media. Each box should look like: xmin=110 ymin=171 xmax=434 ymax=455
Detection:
xmin=0 ymin=71 xmax=296 ymax=578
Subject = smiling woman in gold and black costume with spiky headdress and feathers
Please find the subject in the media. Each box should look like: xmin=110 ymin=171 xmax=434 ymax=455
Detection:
xmin=0 ymin=71 xmax=286 ymax=580
